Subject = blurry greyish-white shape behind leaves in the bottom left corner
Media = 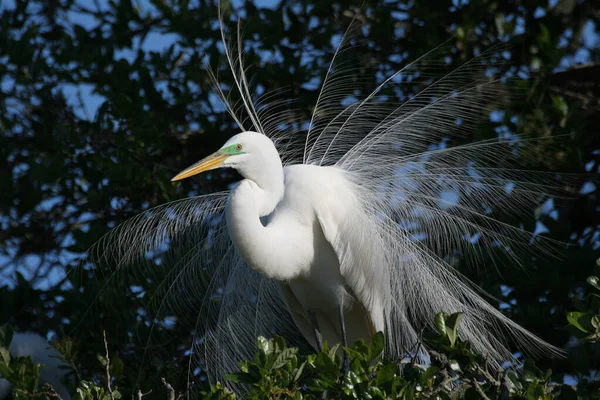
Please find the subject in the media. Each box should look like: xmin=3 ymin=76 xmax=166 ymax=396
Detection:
xmin=0 ymin=332 xmax=71 ymax=400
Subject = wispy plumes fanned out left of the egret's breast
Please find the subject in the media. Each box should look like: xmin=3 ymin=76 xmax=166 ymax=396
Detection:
xmin=72 ymin=192 xmax=306 ymax=390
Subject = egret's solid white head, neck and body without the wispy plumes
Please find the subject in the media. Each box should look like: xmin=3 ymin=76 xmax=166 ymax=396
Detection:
xmin=173 ymin=132 xmax=384 ymax=356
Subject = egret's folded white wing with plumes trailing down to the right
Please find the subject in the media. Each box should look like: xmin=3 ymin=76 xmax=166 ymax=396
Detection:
xmin=316 ymin=162 xmax=559 ymax=367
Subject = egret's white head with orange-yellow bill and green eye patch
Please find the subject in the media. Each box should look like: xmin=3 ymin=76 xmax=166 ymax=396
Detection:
xmin=171 ymin=131 xmax=281 ymax=181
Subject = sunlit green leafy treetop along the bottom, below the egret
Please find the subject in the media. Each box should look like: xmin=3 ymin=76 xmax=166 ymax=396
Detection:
xmin=0 ymin=313 xmax=600 ymax=400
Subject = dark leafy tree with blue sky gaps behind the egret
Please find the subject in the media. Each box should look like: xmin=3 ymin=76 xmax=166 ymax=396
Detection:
xmin=0 ymin=0 xmax=600 ymax=396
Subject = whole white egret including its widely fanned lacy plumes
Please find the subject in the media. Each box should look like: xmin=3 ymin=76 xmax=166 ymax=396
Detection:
xmin=86 ymin=8 xmax=555 ymax=390
